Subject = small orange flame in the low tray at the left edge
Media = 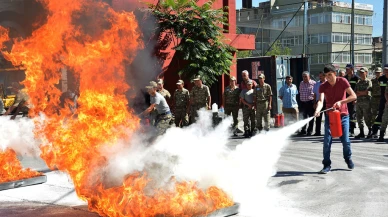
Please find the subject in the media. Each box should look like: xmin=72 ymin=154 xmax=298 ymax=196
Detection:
xmin=0 ymin=149 xmax=42 ymax=183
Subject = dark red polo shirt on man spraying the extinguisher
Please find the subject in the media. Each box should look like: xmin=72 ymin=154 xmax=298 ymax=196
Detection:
xmin=319 ymin=77 xmax=350 ymax=115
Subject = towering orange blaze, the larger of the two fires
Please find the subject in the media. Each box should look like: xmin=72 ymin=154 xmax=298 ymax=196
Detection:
xmin=0 ymin=0 xmax=233 ymax=216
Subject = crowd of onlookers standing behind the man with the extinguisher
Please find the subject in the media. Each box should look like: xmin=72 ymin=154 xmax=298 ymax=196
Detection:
xmin=279 ymin=64 xmax=388 ymax=142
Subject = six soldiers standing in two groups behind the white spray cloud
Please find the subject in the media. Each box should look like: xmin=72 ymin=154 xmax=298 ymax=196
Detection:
xmin=140 ymin=70 xmax=272 ymax=137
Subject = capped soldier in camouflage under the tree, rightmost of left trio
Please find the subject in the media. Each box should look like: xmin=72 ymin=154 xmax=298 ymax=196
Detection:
xmin=190 ymin=75 xmax=211 ymax=123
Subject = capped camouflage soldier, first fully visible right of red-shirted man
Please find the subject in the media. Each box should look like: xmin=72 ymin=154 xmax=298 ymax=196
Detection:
xmin=354 ymin=68 xmax=372 ymax=139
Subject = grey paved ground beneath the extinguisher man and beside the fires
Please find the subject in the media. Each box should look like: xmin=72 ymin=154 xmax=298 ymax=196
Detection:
xmin=0 ymin=123 xmax=388 ymax=217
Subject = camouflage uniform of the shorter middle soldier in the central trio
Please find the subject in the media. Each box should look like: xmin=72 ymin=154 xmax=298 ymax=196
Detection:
xmin=240 ymin=89 xmax=256 ymax=134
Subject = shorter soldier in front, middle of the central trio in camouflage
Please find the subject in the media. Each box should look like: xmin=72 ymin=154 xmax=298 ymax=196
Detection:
xmin=240 ymin=80 xmax=256 ymax=138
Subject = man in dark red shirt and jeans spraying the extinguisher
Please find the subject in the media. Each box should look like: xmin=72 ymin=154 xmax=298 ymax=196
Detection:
xmin=315 ymin=65 xmax=357 ymax=174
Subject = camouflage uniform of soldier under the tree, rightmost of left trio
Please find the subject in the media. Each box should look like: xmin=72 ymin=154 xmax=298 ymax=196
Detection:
xmin=190 ymin=84 xmax=210 ymax=123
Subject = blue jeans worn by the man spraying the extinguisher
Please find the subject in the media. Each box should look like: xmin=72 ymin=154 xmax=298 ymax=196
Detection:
xmin=322 ymin=114 xmax=352 ymax=166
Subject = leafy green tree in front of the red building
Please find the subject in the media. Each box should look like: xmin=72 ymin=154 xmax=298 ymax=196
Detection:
xmin=148 ymin=0 xmax=235 ymax=84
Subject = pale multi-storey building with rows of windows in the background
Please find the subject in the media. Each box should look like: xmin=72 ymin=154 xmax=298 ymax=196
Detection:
xmin=237 ymin=0 xmax=373 ymax=74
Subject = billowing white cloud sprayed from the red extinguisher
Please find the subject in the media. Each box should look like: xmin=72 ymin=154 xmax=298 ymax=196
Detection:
xmin=102 ymin=111 xmax=312 ymax=216
